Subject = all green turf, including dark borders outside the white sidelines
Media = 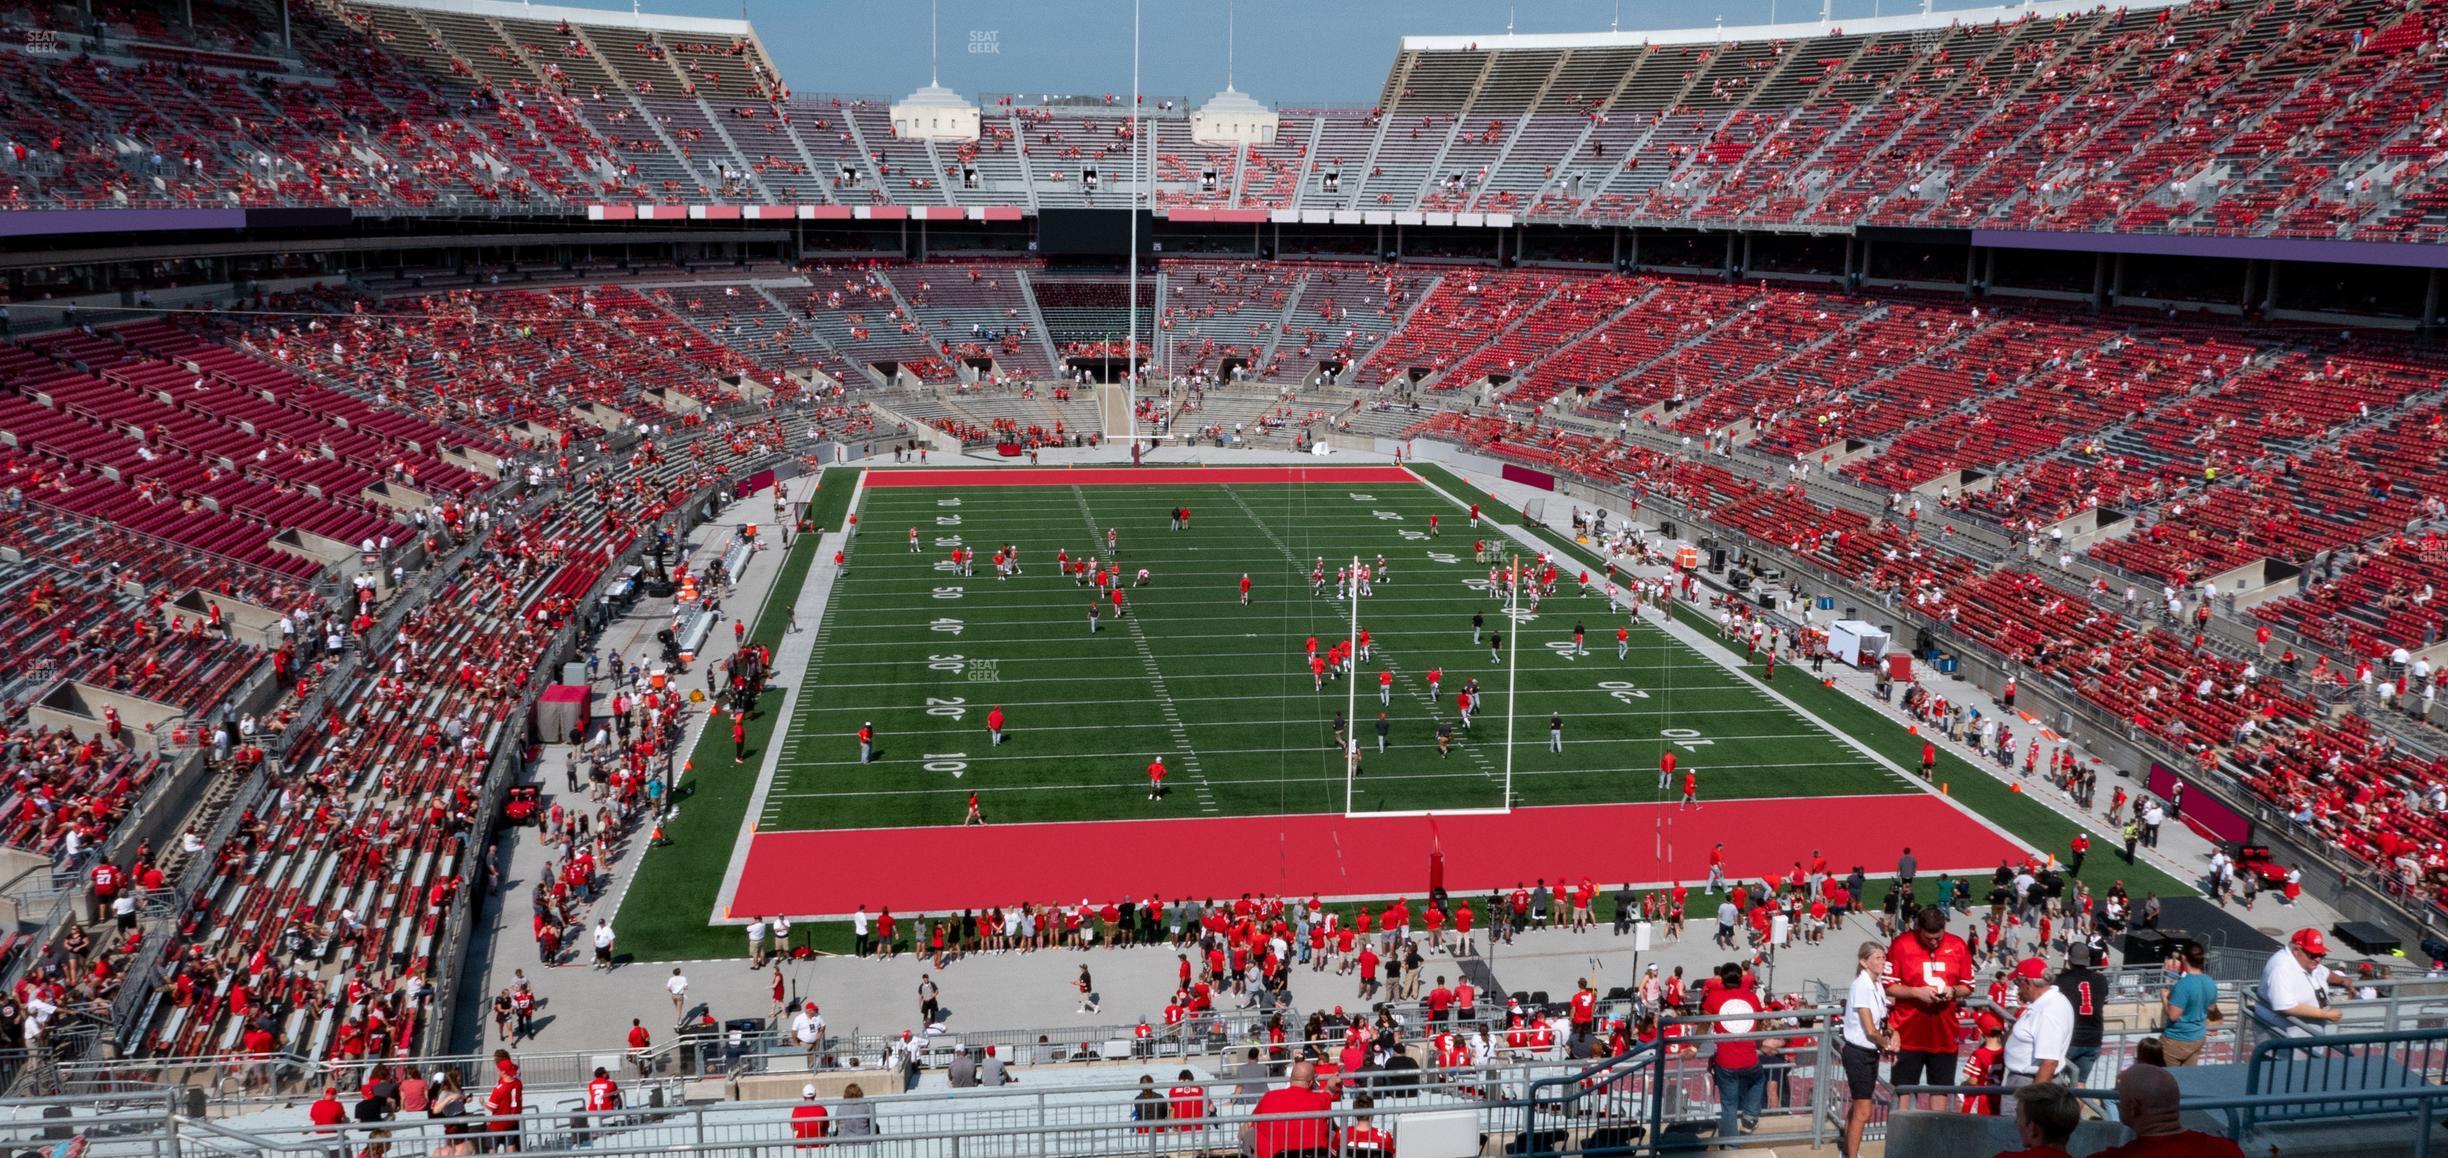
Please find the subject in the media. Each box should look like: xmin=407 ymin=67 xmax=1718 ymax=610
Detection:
xmin=617 ymin=465 xmax=2184 ymax=960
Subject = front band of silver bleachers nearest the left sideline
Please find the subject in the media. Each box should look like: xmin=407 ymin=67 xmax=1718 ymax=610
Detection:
xmin=112 ymin=299 xmax=802 ymax=1058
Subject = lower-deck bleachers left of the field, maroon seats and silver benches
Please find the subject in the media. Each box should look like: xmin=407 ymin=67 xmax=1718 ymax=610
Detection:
xmin=0 ymin=261 xmax=842 ymax=1058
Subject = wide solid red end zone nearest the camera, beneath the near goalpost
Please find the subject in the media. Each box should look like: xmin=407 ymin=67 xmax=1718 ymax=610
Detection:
xmin=732 ymin=786 xmax=2024 ymax=921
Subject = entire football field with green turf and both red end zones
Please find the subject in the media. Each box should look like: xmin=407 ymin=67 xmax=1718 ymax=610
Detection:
xmin=695 ymin=468 xmax=2046 ymax=923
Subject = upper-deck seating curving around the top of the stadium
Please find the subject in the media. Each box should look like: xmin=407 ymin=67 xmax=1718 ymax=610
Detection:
xmin=0 ymin=0 xmax=2448 ymax=240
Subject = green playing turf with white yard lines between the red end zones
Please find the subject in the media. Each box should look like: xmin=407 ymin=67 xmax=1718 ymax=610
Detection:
xmin=752 ymin=474 xmax=1909 ymax=830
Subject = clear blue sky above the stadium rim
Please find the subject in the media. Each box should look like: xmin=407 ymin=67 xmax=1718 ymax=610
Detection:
xmin=561 ymin=0 xmax=2026 ymax=105
